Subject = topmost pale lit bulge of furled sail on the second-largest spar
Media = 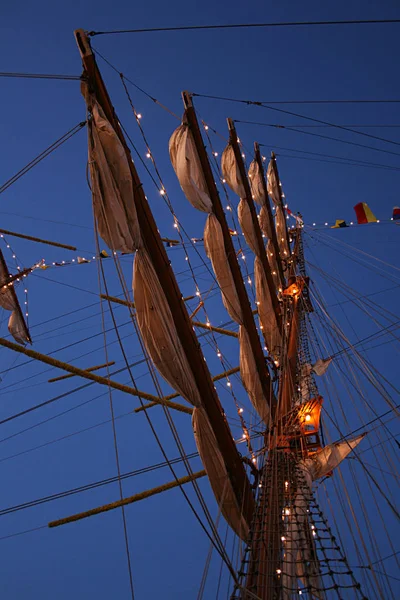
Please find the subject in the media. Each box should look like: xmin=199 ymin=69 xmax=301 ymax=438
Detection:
xmin=169 ymin=123 xmax=212 ymax=213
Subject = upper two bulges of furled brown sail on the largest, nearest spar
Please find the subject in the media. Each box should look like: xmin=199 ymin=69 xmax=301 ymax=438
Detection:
xmin=83 ymin=84 xmax=200 ymax=406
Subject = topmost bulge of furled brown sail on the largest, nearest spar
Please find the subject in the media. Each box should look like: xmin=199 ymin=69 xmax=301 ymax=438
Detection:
xmin=82 ymin=83 xmax=141 ymax=252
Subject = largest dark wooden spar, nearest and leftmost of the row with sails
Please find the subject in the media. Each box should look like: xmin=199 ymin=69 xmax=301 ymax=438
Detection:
xmin=75 ymin=29 xmax=254 ymax=523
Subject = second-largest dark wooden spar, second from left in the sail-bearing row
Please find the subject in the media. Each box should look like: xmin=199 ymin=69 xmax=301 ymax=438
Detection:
xmin=182 ymin=92 xmax=275 ymax=418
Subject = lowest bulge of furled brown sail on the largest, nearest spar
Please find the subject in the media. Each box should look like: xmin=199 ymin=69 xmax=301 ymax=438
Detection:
xmin=192 ymin=408 xmax=248 ymax=541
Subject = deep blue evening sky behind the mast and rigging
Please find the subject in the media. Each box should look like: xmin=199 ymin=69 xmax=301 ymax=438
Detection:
xmin=0 ymin=0 xmax=400 ymax=600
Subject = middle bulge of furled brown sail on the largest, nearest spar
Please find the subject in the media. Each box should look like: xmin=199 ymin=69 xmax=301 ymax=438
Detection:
xmin=133 ymin=249 xmax=201 ymax=406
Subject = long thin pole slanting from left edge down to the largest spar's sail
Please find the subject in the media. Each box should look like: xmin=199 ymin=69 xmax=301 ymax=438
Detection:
xmin=0 ymin=338 xmax=192 ymax=415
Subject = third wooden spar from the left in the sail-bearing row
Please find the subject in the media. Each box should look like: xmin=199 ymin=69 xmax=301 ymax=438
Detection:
xmin=227 ymin=119 xmax=282 ymax=331
